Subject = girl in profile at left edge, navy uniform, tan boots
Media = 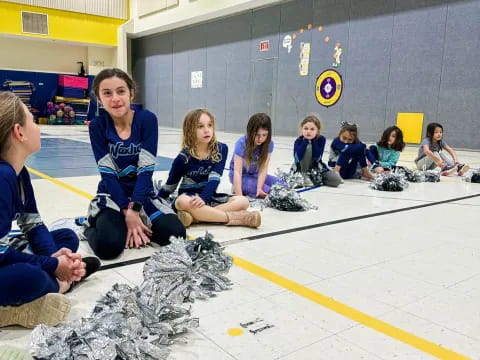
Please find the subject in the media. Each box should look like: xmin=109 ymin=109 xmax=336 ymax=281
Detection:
xmin=0 ymin=92 xmax=99 ymax=327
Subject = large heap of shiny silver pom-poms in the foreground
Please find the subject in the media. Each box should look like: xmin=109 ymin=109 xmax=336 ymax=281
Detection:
xmin=31 ymin=233 xmax=233 ymax=360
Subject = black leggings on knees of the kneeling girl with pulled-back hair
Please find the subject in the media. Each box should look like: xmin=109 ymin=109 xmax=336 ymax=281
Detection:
xmin=85 ymin=208 xmax=186 ymax=260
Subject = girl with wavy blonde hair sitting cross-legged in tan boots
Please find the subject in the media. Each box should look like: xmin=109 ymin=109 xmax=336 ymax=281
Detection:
xmin=160 ymin=109 xmax=261 ymax=227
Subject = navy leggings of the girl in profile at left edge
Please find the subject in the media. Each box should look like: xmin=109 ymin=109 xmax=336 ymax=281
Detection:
xmin=0 ymin=229 xmax=78 ymax=306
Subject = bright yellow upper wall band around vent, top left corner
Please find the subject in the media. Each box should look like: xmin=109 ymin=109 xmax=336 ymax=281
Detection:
xmin=0 ymin=1 xmax=125 ymax=46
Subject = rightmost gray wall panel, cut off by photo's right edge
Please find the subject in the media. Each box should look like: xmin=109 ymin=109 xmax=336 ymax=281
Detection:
xmin=438 ymin=1 xmax=480 ymax=149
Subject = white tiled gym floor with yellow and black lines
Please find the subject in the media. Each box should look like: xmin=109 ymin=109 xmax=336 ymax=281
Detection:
xmin=0 ymin=126 xmax=480 ymax=360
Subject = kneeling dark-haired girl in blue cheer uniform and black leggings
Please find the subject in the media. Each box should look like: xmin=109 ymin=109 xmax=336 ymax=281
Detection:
xmin=85 ymin=69 xmax=185 ymax=259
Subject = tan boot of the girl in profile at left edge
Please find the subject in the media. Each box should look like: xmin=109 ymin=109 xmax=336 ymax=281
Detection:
xmin=0 ymin=293 xmax=70 ymax=328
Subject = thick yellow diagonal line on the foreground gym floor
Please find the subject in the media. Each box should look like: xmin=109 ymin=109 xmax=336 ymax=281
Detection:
xmin=229 ymin=254 xmax=472 ymax=360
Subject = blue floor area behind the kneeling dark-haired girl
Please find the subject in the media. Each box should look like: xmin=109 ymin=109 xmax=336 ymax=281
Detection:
xmin=26 ymin=138 xmax=173 ymax=179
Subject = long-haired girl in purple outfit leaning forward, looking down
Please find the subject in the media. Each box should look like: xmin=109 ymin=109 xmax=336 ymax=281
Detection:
xmin=229 ymin=113 xmax=281 ymax=197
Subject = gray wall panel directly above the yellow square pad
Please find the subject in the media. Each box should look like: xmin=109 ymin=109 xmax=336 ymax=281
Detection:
xmin=387 ymin=2 xmax=447 ymax=131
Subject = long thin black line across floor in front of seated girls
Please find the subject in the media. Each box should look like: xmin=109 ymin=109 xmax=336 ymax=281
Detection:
xmin=98 ymin=194 xmax=480 ymax=271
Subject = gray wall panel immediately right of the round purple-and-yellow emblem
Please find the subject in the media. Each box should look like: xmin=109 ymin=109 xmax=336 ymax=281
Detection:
xmin=342 ymin=0 xmax=396 ymax=140
